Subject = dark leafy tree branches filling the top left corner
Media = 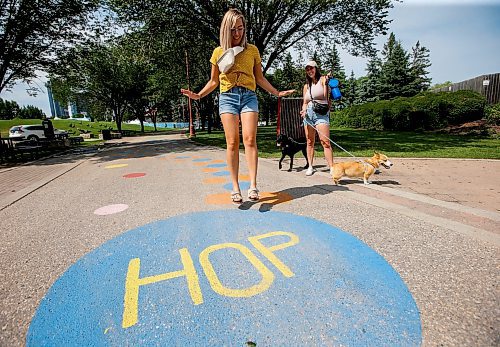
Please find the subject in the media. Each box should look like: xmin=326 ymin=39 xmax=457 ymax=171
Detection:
xmin=0 ymin=0 xmax=99 ymax=92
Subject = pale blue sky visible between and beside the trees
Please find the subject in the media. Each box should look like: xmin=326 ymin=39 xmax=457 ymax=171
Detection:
xmin=0 ymin=0 xmax=500 ymax=115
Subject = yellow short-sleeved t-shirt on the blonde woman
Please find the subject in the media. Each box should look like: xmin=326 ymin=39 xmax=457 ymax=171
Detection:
xmin=210 ymin=44 xmax=262 ymax=93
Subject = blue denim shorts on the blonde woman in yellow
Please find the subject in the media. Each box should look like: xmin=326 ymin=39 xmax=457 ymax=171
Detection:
xmin=219 ymin=87 xmax=259 ymax=115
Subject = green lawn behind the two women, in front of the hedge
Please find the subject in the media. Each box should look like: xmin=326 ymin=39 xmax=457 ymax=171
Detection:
xmin=193 ymin=127 xmax=500 ymax=159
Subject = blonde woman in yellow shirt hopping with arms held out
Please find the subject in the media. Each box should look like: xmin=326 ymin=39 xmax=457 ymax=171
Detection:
xmin=181 ymin=9 xmax=295 ymax=204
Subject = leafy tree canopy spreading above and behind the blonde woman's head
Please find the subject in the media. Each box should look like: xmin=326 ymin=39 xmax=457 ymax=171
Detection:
xmin=110 ymin=0 xmax=393 ymax=72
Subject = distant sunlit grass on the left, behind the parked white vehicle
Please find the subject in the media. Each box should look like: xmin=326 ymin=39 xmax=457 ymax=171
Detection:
xmin=0 ymin=118 xmax=179 ymax=138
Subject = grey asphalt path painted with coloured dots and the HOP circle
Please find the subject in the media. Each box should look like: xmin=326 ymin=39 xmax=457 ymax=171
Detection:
xmin=0 ymin=135 xmax=500 ymax=346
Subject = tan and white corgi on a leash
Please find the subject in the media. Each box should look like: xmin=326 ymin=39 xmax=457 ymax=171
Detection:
xmin=330 ymin=152 xmax=393 ymax=185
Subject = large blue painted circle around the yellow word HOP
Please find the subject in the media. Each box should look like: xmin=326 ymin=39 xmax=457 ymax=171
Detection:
xmin=26 ymin=210 xmax=421 ymax=346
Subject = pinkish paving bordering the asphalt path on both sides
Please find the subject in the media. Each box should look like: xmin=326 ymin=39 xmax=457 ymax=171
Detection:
xmin=0 ymin=134 xmax=500 ymax=233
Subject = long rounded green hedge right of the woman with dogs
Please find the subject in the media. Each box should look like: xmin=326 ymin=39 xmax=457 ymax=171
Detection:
xmin=331 ymin=90 xmax=486 ymax=130
